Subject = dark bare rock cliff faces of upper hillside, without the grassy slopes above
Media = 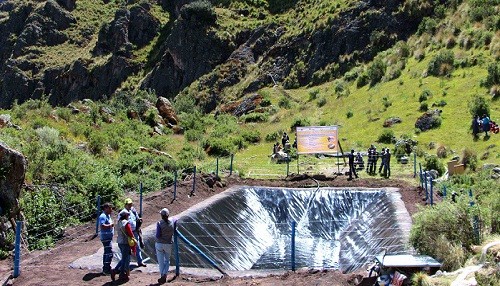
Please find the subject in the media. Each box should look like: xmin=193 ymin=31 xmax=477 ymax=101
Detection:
xmin=0 ymin=0 xmax=432 ymax=112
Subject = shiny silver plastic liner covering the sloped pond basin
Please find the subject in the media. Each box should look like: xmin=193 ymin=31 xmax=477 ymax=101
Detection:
xmin=141 ymin=186 xmax=411 ymax=272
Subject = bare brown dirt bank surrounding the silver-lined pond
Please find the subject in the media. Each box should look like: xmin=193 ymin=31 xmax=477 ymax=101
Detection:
xmin=0 ymin=176 xmax=423 ymax=286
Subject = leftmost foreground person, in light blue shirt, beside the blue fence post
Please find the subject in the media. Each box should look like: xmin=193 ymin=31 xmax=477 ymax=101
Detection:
xmin=99 ymin=203 xmax=114 ymax=275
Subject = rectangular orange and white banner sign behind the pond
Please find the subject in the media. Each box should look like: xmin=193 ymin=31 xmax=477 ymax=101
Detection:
xmin=297 ymin=126 xmax=338 ymax=154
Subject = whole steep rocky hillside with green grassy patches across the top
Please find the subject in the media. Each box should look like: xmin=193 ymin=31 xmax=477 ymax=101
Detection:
xmin=0 ymin=0 xmax=438 ymax=109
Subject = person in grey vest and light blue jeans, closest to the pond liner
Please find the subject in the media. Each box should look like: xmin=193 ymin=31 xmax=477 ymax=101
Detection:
xmin=155 ymin=208 xmax=175 ymax=284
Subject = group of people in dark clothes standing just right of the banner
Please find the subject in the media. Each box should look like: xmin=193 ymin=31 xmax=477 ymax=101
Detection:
xmin=347 ymin=144 xmax=391 ymax=180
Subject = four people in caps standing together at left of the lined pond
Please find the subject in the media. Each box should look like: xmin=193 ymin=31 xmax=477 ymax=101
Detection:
xmin=99 ymin=198 xmax=175 ymax=284
